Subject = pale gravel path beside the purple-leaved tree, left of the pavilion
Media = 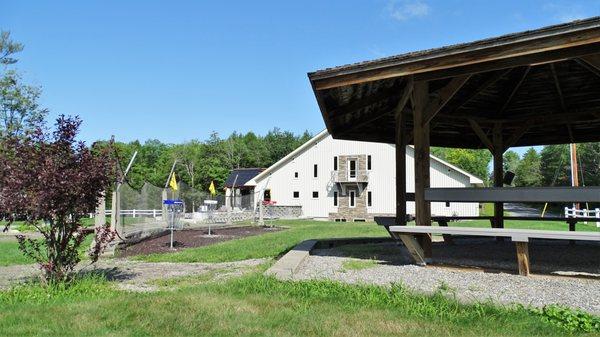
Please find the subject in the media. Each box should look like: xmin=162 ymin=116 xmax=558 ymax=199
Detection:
xmin=0 ymin=259 xmax=265 ymax=291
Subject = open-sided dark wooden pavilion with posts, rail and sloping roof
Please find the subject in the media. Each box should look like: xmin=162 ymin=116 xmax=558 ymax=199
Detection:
xmin=308 ymin=17 xmax=600 ymax=270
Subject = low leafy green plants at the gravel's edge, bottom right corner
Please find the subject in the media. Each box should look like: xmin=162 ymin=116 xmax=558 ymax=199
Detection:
xmin=531 ymin=305 xmax=600 ymax=332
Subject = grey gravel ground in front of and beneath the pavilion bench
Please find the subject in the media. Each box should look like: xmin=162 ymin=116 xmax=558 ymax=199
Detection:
xmin=293 ymin=243 xmax=600 ymax=314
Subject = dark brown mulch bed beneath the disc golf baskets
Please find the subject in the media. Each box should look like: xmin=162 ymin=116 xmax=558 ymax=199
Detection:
xmin=119 ymin=226 xmax=282 ymax=257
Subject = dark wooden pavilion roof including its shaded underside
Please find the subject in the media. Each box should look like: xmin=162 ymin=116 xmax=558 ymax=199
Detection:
xmin=309 ymin=17 xmax=600 ymax=148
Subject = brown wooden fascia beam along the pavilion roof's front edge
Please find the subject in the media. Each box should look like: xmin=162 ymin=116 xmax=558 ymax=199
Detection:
xmin=309 ymin=29 xmax=600 ymax=90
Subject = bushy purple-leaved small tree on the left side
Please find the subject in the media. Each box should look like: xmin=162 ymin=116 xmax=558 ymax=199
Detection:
xmin=0 ymin=116 xmax=115 ymax=282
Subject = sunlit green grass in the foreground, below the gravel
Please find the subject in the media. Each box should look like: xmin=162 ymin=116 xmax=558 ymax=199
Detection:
xmin=0 ymin=274 xmax=597 ymax=337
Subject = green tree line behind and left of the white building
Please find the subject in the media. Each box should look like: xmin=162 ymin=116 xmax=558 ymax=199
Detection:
xmin=96 ymin=128 xmax=312 ymax=191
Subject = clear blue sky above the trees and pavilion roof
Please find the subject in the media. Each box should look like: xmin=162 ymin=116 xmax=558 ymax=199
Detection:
xmin=0 ymin=0 xmax=600 ymax=152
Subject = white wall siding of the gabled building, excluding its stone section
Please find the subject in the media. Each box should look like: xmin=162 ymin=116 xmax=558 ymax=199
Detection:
xmin=249 ymin=131 xmax=479 ymax=218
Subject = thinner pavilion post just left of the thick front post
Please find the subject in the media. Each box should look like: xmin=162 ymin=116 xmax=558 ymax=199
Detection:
xmin=396 ymin=104 xmax=406 ymax=226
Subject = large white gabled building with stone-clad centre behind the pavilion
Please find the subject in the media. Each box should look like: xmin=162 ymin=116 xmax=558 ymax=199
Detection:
xmin=245 ymin=130 xmax=483 ymax=221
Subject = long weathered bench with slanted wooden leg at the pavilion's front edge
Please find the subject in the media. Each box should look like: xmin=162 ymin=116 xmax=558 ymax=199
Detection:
xmin=388 ymin=226 xmax=600 ymax=276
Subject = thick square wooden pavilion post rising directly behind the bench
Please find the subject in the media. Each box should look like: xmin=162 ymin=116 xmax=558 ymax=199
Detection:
xmin=412 ymin=82 xmax=431 ymax=259
